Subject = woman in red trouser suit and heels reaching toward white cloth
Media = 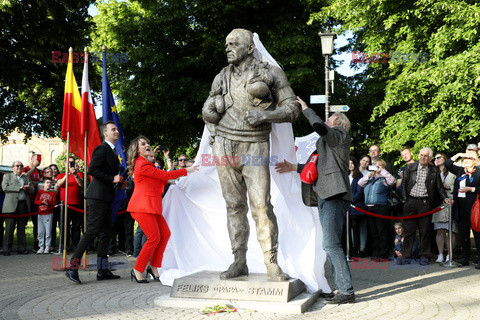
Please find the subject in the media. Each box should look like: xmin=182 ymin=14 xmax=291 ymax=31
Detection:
xmin=127 ymin=136 xmax=198 ymax=283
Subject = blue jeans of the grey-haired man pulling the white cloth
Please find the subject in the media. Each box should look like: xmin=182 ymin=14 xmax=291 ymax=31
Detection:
xmin=318 ymin=199 xmax=354 ymax=294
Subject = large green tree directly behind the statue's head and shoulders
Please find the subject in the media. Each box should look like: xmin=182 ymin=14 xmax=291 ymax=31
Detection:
xmin=92 ymin=0 xmax=338 ymax=154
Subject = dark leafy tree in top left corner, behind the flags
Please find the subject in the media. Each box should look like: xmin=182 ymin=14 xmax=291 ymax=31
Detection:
xmin=0 ymin=0 xmax=94 ymax=140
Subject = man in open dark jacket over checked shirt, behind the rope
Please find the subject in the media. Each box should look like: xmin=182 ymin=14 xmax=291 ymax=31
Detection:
xmin=401 ymin=148 xmax=453 ymax=265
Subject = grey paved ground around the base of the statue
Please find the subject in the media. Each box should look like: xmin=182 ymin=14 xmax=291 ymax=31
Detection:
xmin=0 ymin=253 xmax=480 ymax=320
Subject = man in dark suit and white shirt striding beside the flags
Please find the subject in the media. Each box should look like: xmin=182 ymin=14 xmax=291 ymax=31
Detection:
xmin=66 ymin=121 xmax=122 ymax=283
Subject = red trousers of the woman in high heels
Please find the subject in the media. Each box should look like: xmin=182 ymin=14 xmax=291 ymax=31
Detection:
xmin=131 ymin=212 xmax=170 ymax=272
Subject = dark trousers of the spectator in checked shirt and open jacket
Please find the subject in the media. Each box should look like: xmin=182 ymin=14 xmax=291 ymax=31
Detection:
xmin=401 ymin=197 xmax=433 ymax=259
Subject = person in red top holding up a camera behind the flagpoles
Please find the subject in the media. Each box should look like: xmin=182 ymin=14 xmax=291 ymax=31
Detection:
xmin=55 ymin=157 xmax=83 ymax=250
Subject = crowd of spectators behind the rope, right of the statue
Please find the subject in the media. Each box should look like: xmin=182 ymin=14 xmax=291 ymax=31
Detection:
xmin=344 ymin=144 xmax=480 ymax=269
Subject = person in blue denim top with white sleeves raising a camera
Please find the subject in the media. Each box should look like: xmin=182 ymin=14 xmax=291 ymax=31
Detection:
xmin=358 ymin=159 xmax=395 ymax=261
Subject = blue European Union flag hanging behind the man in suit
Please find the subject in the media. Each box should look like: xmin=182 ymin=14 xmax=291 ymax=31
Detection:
xmin=102 ymin=51 xmax=127 ymax=221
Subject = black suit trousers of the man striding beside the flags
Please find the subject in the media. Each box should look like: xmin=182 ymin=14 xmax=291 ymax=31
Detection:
xmin=70 ymin=199 xmax=112 ymax=270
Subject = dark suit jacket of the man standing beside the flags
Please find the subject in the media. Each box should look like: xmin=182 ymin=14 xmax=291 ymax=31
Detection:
xmin=85 ymin=142 xmax=119 ymax=202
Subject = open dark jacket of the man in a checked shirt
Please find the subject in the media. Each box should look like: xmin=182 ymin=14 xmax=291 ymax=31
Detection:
xmin=402 ymin=162 xmax=448 ymax=208
